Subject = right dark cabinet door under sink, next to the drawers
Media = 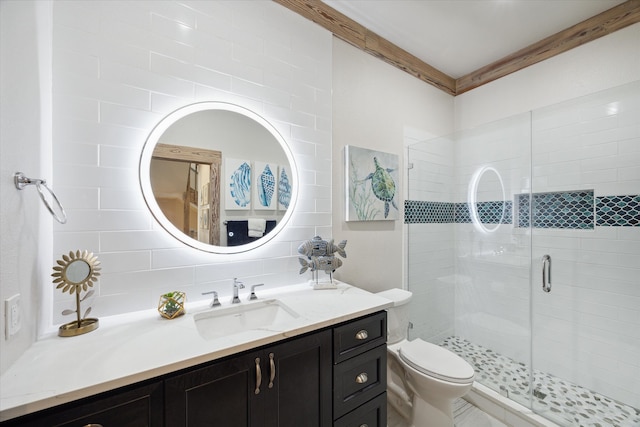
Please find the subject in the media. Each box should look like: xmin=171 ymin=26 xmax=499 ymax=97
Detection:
xmin=260 ymin=330 xmax=332 ymax=427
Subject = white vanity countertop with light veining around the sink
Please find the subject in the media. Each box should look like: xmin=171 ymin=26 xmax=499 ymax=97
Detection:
xmin=0 ymin=283 xmax=391 ymax=421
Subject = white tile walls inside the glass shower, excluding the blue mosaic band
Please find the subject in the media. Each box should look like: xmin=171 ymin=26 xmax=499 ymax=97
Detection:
xmin=409 ymin=82 xmax=640 ymax=408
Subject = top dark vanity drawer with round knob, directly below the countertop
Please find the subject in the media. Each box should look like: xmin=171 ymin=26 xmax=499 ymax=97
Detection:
xmin=333 ymin=311 xmax=387 ymax=363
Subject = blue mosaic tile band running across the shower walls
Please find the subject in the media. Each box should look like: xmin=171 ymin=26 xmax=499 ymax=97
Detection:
xmin=404 ymin=190 xmax=640 ymax=230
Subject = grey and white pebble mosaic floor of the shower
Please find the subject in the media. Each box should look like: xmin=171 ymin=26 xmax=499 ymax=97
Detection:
xmin=440 ymin=337 xmax=640 ymax=427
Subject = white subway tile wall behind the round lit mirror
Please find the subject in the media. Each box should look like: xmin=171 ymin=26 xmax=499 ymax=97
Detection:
xmin=51 ymin=1 xmax=331 ymax=325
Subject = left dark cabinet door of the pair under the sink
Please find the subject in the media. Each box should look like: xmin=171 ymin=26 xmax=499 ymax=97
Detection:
xmin=165 ymin=353 xmax=263 ymax=427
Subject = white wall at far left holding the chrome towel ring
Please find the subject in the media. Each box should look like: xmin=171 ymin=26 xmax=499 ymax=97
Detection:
xmin=0 ymin=1 xmax=53 ymax=372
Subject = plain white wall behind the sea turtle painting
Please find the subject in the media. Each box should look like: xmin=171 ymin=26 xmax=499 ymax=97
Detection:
xmin=330 ymin=39 xmax=453 ymax=291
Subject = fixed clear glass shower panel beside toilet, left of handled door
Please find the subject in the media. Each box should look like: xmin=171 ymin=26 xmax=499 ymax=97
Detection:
xmin=405 ymin=114 xmax=531 ymax=407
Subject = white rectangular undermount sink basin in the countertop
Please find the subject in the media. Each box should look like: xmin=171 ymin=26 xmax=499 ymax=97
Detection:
xmin=193 ymin=299 xmax=300 ymax=339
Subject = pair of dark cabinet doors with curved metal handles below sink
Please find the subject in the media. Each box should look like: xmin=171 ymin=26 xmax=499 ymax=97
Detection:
xmin=165 ymin=330 xmax=332 ymax=427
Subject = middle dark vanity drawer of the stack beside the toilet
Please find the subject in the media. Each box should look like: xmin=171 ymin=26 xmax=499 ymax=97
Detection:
xmin=333 ymin=344 xmax=387 ymax=419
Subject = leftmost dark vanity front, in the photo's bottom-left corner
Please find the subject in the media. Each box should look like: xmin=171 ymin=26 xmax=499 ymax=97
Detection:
xmin=2 ymin=381 xmax=163 ymax=427
